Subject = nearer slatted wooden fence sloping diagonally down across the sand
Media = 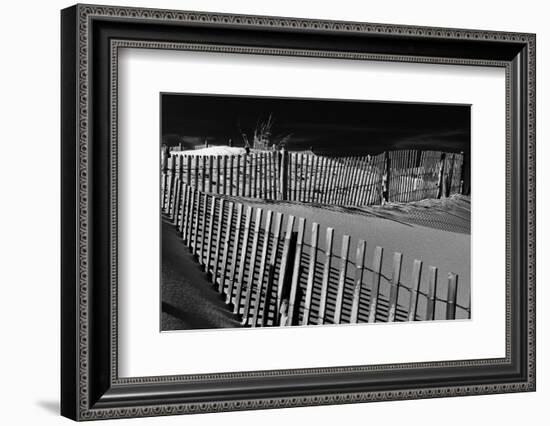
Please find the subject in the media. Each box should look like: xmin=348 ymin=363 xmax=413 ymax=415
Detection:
xmin=163 ymin=179 xmax=469 ymax=327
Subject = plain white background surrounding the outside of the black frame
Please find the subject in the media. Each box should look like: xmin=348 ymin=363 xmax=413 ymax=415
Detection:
xmin=0 ymin=0 xmax=550 ymax=426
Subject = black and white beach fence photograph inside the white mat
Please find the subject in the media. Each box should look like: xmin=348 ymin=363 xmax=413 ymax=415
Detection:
xmin=160 ymin=93 xmax=472 ymax=331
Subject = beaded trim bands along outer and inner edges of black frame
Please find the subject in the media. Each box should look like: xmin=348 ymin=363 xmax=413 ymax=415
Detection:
xmin=71 ymin=5 xmax=536 ymax=420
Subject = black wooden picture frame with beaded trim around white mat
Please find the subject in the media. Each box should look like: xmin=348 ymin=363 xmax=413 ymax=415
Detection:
xmin=61 ymin=5 xmax=535 ymax=420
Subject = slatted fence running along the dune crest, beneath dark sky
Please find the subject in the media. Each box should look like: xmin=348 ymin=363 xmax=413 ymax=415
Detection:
xmin=163 ymin=150 xmax=464 ymax=206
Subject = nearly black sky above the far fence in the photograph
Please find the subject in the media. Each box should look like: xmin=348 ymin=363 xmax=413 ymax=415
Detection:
xmin=161 ymin=94 xmax=470 ymax=155
